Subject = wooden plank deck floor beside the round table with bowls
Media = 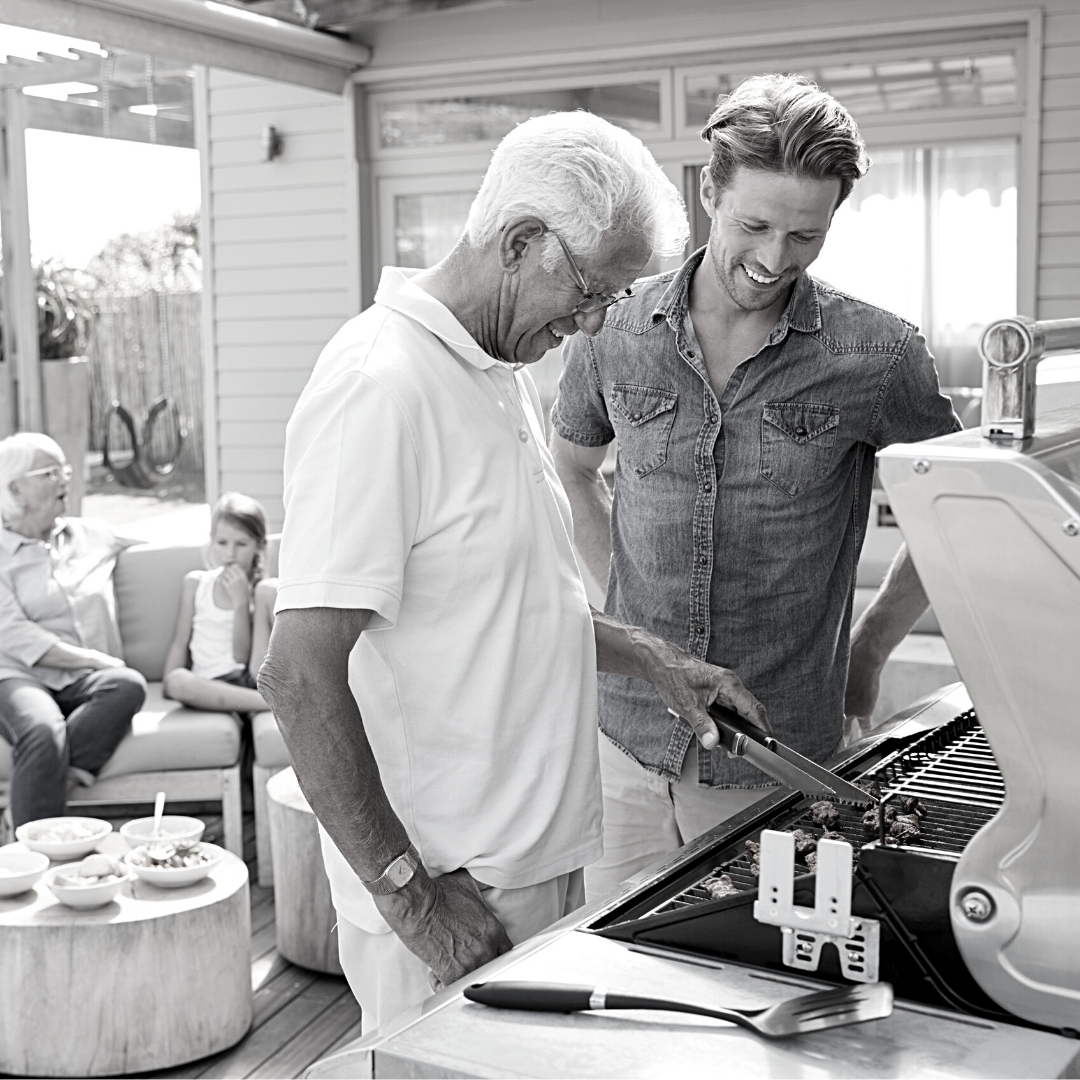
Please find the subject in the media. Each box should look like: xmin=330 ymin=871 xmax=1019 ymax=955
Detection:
xmin=133 ymin=814 xmax=360 ymax=1078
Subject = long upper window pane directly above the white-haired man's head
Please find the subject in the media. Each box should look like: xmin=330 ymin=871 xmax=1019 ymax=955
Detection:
xmin=378 ymin=82 xmax=660 ymax=148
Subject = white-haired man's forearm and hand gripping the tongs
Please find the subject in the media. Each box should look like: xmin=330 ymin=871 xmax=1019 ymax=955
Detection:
xmin=593 ymin=611 xmax=772 ymax=750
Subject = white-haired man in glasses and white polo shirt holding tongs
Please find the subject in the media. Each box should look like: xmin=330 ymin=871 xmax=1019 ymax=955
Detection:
xmin=259 ymin=112 xmax=765 ymax=1029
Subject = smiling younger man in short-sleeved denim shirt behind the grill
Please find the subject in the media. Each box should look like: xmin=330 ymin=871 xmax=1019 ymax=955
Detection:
xmin=552 ymin=76 xmax=959 ymax=899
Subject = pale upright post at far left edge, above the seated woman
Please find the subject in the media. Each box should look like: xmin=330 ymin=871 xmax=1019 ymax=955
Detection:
xmin=0 ymin=90 xmax=42 ymax=431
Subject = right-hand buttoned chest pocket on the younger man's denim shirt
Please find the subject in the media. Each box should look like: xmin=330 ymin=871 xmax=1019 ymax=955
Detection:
xmin=761 ymin=402 xmax=840 ymax=498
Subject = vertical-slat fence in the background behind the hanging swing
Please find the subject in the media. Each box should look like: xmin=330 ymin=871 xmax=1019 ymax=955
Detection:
xmin=90 ymin=293 xmax=204 ymax=473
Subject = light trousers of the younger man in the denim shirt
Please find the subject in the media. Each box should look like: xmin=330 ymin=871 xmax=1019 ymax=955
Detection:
xmin=585 ymin=731 xmax=769 ymax=903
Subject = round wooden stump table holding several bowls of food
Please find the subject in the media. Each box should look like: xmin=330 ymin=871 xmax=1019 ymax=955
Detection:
xmin=0 ymin=833 xmax=252 ymax=1077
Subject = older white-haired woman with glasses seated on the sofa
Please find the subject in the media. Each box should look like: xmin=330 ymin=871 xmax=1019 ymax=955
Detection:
xmin=0 ymin=432 xmax=146 ymax=827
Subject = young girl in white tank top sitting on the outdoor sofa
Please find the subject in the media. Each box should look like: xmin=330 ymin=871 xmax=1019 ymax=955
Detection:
xmin=163 ymin=491 xmax=276 ymax=713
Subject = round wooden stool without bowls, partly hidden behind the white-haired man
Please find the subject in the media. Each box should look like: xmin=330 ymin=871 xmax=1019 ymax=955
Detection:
xmin=267 ymin=769 xmax=342 ymax=975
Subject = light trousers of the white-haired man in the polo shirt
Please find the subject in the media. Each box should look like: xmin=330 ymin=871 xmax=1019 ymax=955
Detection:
xmin=338 ymin=869 xmax=585 ymax=1035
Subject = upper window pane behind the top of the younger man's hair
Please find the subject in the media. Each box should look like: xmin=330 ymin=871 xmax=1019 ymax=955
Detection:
xmin=685 ymin=52 xmax=1020 ymax=127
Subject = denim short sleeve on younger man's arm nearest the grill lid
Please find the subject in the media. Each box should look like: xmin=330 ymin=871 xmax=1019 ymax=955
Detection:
xmin=866 ymin=333 xmax=963 ymax=449
